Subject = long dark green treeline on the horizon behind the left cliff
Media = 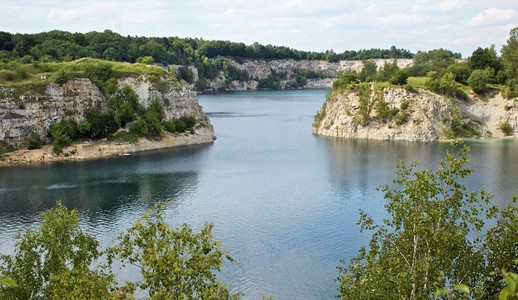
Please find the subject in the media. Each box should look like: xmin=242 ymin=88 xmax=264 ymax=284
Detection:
xmin=0 ymin=30 xmax=413 ymax=65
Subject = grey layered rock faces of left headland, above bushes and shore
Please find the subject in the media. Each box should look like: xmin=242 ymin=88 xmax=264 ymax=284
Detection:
xmin=0 ymin=77 xmax=214 ymax=144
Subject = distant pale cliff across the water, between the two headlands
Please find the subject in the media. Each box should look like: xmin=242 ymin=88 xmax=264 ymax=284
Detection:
xmin=174 ymin=58 xmax=413 ymax=92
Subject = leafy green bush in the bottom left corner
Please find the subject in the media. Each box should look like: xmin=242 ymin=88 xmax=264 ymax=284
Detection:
xmin=0 ymin=202 xmax=114 ymax=299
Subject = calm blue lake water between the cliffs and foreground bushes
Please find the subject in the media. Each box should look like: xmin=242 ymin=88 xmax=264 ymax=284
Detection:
xmin=0 ymin=90 xmax=518 ymax=299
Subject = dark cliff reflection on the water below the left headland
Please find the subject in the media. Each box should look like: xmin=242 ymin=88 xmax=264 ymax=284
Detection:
xmin=0 ymin=146 xmax=210 ymax=252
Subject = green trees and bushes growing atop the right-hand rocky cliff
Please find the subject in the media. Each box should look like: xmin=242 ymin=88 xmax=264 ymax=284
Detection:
xmin=333 ymin=27 xmax=518 ymax=99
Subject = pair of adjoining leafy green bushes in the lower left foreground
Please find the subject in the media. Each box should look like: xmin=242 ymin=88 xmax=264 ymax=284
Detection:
xmin=0 ymin=202 xmax=239 ymax=299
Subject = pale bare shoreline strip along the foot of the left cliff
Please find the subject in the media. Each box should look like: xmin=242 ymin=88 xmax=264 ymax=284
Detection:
xmin=0 ymin=130 xmax=215 ymax=167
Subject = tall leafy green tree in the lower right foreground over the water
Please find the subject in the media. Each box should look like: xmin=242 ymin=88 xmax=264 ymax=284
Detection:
xmin=338 ymin=147 xmax=495 ymax=299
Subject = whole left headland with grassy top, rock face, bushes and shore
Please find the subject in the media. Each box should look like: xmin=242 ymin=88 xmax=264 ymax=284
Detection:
xmin=0 ymin=59 xmax=214 ymax=163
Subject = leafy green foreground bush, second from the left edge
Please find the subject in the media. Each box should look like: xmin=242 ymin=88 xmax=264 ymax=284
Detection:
xmin=108 ymin=207 xmax=239 ymax=299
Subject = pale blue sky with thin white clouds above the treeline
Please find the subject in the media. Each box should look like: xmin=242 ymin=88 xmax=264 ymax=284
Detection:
xmin=0 ymin=0 xmax=518 ymax=57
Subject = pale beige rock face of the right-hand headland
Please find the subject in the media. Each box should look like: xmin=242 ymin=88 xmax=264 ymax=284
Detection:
xmin=313 ymin=85 xmax=518 ymax=141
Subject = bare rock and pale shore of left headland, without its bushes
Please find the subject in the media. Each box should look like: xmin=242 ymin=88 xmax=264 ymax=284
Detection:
xmin=0 ymin=59 xmax=215 ymax=165
